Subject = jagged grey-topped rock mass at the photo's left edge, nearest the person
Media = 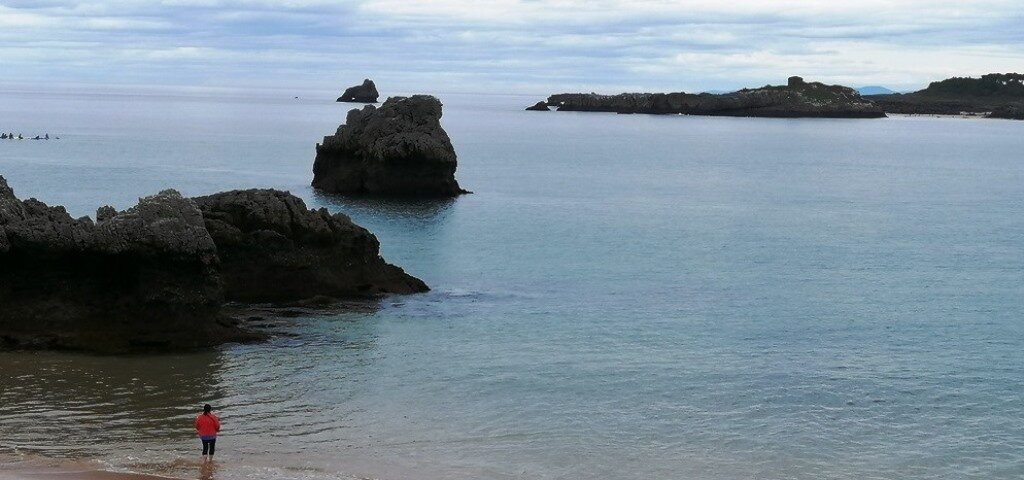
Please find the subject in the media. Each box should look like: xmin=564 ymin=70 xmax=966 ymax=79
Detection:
xmin=0 ymin=177 xmax=245 ymax=351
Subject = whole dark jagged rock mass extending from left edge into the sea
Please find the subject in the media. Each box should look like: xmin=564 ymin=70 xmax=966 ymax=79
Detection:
xmin=0 ymin=177 xmax=427 ymax=353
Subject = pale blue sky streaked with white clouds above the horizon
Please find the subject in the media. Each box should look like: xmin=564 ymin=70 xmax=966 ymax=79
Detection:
xmin=0 ymin=0 xmax=1024 ymax=94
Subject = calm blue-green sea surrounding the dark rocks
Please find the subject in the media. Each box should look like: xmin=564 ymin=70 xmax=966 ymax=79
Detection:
xmin=0 ymin=88 xmax=1024 ymax=480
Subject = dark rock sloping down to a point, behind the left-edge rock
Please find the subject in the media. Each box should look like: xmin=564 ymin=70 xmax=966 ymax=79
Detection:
xmin=196 ymin=190 xmax=428 ymax=302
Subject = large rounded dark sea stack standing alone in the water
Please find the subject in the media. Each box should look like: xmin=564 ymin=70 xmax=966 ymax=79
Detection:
xmin=312 ymin=95 xmax=466 ymax=197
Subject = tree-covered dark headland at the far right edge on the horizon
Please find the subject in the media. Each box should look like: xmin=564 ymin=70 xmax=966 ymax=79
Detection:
xmin=865 ymin=74 xmax=1024 ymax=120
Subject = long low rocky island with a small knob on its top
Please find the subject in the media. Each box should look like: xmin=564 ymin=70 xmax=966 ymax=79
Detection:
xmin=529 ymin=77 xmax=885 ymax=119
